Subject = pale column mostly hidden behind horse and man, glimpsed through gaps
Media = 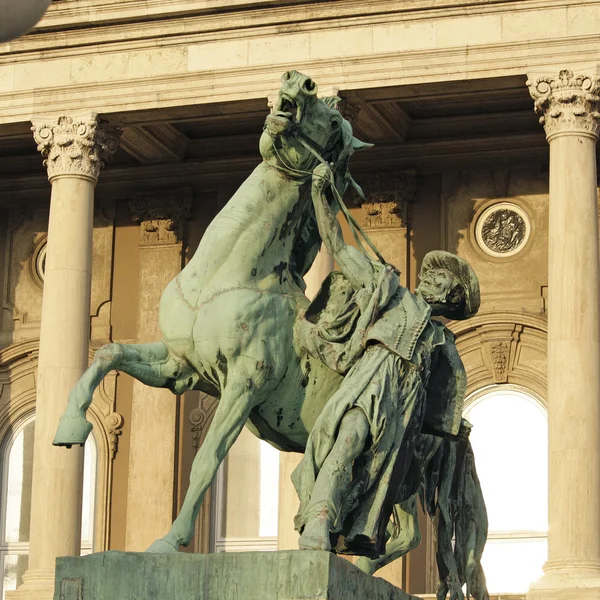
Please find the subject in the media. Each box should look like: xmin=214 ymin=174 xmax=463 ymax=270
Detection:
xmin=277 ymin=245 xmax=333 ymax=550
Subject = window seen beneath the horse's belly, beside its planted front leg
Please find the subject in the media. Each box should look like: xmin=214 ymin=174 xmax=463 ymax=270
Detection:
xmin=212 ymin=429 xmax=279 ymax=552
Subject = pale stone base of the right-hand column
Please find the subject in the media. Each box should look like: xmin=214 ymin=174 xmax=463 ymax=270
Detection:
xmin=527 ymin=561 xmax=600 ymax=600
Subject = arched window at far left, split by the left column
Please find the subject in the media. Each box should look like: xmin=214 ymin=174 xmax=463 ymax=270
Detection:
xmin=0 ymin=415 xmax=97 ymax=600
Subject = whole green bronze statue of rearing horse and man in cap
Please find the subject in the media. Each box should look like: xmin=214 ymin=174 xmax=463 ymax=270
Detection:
xmin=54 ymin=71 xmax=487 ymax=600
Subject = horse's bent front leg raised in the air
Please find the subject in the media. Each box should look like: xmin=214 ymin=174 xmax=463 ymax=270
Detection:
xmin=52 ymin=342 xmax=198 ymax=448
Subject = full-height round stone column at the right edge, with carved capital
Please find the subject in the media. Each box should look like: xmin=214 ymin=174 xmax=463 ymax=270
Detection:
xmin=527 ymin=70 xmax=600 ymax=600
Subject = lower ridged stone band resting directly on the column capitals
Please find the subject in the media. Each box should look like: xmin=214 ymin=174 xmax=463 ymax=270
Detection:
xmin=0 ymin=34 xmax=600 ymax=125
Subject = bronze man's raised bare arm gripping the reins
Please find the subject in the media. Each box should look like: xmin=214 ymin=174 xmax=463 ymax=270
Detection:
xmin=312 ymin=164 xmax=375 ymax=290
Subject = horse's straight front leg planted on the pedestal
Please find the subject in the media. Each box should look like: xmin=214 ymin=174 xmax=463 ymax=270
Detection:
xmin=147 ymin=377 xmax=258 ymax=553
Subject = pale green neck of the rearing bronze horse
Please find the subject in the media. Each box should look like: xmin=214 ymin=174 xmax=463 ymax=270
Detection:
xmin=190 ymin=162 xmax=309 ymax=278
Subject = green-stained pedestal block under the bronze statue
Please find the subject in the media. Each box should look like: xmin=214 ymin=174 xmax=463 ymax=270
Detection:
xmin=54 ymin=550 xmax=422 ymax=600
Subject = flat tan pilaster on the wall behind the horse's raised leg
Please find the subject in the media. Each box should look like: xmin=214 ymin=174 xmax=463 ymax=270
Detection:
xmin=125 ymin=188 xmax=192 ymax=552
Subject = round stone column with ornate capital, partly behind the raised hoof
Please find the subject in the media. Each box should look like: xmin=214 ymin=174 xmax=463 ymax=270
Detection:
xmin=7 ymin=113 xmax=118 ymax=600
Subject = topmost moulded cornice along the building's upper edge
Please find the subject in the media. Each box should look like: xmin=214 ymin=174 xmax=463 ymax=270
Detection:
xmin=0 ymin=0 xmax=598 ymax=60
